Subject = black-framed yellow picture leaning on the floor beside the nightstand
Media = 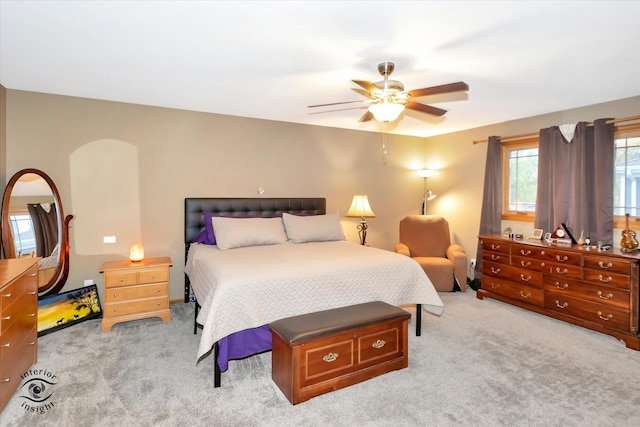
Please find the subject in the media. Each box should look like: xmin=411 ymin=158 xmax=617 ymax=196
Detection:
xmin=38 ymin=285 xmax=102 ymax=337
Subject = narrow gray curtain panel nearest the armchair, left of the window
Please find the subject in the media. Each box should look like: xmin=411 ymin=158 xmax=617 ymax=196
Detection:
xmin=474 ymin=136 xmax=502 ymax=277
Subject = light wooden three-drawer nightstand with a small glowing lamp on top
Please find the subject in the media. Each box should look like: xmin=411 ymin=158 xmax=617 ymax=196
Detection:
xmin=100 ymin=257 xmax=171 ymax=332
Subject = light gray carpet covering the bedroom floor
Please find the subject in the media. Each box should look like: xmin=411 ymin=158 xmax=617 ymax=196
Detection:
xmin=0 ymin=290 xmax=640 ymax=427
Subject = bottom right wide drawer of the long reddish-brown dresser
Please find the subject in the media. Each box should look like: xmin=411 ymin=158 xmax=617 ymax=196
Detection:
xmin=544 ymin=292 xmax=631 ymax=331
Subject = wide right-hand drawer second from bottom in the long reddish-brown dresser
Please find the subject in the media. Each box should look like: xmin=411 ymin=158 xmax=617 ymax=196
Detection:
xmin=544 ymin=276 xmax=630 ymax=310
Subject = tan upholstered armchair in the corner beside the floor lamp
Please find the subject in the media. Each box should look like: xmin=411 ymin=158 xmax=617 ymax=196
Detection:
xmin=394 ymin=215 xmax=467 ymax=292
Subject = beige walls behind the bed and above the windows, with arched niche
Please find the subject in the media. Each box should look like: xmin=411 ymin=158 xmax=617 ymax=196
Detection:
xmin=2 ymin=90 xmax=640 ymax=300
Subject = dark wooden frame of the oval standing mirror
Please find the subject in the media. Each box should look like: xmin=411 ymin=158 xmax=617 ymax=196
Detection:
xmin=1 ymin=169 xmax=73 ymax=297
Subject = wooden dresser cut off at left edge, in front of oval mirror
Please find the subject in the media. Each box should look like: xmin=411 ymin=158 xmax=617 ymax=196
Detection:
xmin=0 ymin=258 xmax=39 ymax=411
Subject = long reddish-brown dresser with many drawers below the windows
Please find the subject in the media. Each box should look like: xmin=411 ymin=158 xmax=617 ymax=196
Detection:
xmin=477 ymin=235 xmax=640 ymax=350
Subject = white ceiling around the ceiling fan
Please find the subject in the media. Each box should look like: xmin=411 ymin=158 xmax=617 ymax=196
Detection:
xmin=0 ymin=0 xmax=640 ymax=136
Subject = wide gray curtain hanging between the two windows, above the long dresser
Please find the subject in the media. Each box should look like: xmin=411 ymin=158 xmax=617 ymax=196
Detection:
xmin=534 ymin=119 xmax=614 ymax=244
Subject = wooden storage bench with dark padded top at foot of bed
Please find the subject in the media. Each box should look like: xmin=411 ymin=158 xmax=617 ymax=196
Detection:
xmin=269 ymin=301 xmax=411 ymax=405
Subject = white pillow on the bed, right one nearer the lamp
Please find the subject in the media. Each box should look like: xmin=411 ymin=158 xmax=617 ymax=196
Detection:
xmin=282 ymin=213 xmax=347 ymax=243
